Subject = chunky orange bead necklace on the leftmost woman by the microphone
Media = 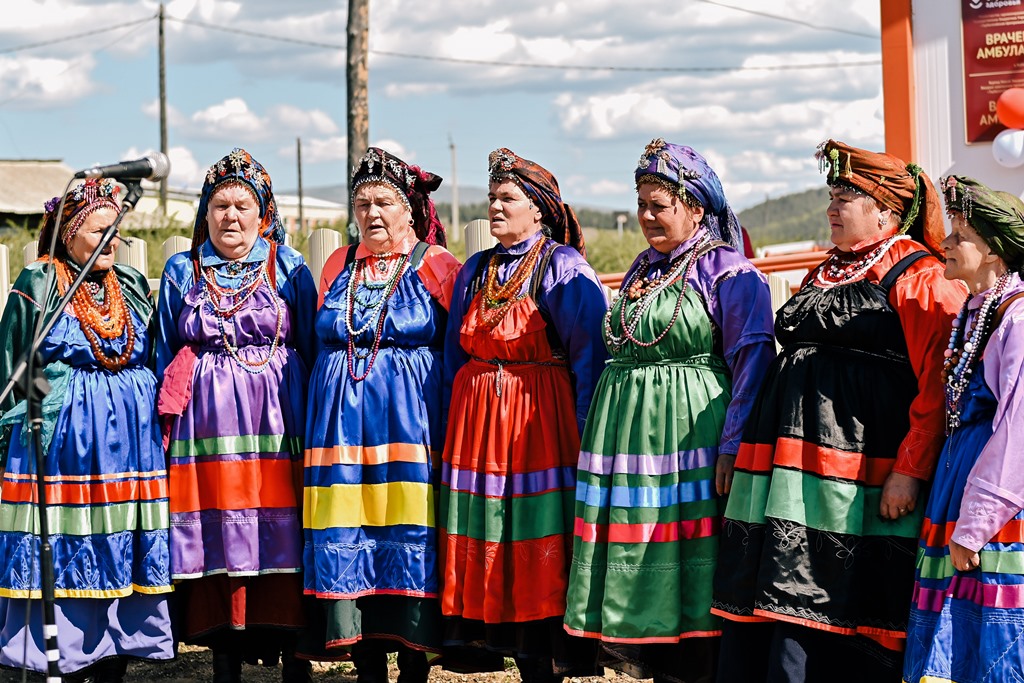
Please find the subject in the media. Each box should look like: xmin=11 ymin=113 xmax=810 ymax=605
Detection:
xmin=56 ymin=260 xmax=135 ymax=373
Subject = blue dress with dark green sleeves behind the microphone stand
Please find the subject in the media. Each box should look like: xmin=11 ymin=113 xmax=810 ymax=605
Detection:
xmin=0 ymin=260 xmax=174 ymax=673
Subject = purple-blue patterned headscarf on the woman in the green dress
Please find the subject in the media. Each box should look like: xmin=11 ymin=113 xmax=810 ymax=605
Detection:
xmin=634 ymin=137 xmax=743 ymax=254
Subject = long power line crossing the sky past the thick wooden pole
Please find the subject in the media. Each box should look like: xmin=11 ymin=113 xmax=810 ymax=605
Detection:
xmin=166 ymin=15 xmax=882 ymax=73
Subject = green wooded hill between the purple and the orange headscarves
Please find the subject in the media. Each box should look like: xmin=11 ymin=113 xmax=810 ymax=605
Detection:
xmin=738 ymin=187 xmax=828 ymax=247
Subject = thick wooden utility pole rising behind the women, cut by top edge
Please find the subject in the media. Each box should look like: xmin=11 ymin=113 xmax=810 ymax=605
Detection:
xmin=345 ymin=0 xmax=370 ymax=244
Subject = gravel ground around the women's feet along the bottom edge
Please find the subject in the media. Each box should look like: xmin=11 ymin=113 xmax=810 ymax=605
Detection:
xmin=0 ymin=645 xmax=622 ymax=683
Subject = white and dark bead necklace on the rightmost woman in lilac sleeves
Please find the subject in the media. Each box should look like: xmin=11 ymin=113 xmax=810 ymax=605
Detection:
xmin=942 ymin=272 xmax=1010 ymax=432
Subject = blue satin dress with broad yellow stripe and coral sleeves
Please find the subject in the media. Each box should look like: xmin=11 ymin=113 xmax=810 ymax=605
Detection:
xmin=303 ymin=236 xmax=459 ymax=655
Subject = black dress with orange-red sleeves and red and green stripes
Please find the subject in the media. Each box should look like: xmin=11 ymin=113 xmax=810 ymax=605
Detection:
xmin=715 ymin=237 xmax=963 ymax=680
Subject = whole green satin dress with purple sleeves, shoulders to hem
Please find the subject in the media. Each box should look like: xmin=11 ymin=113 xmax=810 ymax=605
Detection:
xmin=565 ymin=228 xmax=775 ymax=680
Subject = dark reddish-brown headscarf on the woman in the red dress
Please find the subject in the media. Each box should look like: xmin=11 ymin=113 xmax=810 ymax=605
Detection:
xmin=487 ymin=147 xmax=587 ymax=257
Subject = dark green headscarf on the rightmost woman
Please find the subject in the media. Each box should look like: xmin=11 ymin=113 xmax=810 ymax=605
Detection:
xmin=942 ymin=175 xmax=1024 ymax=271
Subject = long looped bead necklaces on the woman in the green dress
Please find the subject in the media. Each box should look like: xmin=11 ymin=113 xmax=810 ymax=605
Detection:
xmin=604 ymin=234 xmax=710 ymax=349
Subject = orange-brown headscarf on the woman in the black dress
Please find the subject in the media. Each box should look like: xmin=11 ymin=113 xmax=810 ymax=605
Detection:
xmin=814 ymin=139 xmax=946 ymax=259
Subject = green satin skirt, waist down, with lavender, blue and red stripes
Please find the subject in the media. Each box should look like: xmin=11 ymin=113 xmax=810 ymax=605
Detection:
xmin=565 ymin=355 xmax=729 ymax=643
